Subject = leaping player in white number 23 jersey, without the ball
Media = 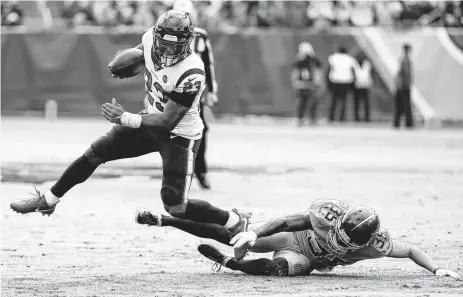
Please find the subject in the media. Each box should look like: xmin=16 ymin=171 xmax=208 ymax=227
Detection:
xmin=10 ymin=10 xmax=250 ymax=238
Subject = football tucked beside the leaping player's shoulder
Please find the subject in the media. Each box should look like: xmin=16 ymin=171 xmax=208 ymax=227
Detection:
xmin=108 ymin=48 xmax=145 ymax=78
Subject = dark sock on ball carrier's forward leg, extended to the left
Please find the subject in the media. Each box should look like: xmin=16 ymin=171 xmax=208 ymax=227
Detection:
xmin=50 ymin=156 xmax=98 ymax=198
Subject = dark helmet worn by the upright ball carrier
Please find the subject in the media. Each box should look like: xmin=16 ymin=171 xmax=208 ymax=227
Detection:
xmin=153 ymin=10 xmax=194 ymax=67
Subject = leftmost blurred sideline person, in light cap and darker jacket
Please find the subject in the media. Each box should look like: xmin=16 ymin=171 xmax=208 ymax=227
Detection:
xmin=291 ymin=42 xmax=321 ymax=127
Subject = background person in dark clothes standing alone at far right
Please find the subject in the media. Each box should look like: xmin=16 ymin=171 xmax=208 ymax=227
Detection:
xmin=394 ymin=43 xmax=413 ymax=128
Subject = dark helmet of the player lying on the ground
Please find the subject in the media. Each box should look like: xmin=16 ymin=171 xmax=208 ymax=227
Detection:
xmin=326 ymin=206 xmax=380 ymax=256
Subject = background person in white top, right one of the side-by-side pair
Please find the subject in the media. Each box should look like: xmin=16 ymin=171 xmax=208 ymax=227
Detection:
xmin=354 ymin=52 xmax=373 ymax=122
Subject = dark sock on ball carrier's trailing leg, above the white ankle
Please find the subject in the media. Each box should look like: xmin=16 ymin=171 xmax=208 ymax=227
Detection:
xmin=184 ymin=199 xmax=230 ymax=226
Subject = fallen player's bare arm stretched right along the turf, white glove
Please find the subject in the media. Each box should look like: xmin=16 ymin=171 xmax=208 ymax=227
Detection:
xmin=388 ymin=239 xmax=460 ymax=278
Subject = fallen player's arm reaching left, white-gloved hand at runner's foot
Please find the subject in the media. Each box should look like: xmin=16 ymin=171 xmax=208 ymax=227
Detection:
xmin=230 ymin=213 xmax=312 ymax=248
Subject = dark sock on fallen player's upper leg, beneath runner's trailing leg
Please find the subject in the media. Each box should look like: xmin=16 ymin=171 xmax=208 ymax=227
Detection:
xmin=161 ymin=215 xmax=231 ymax=245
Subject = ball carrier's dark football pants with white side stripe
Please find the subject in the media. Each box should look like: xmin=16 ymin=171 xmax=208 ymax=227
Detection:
xmin=85 ymin=126 xmax=201 ymax=206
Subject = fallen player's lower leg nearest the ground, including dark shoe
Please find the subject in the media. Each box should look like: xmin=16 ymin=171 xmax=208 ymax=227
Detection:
xmin=198 ymin=244 xmax=289 ymax=276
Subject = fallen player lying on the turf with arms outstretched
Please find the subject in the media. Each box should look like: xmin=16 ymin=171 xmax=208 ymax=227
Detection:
xmin=136 ymin=200 xmax=460 ymax=278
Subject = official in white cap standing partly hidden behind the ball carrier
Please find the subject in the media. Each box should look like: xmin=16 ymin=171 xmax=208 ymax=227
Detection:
xmin=173 ymin=0 xmax=218 ymax=189
